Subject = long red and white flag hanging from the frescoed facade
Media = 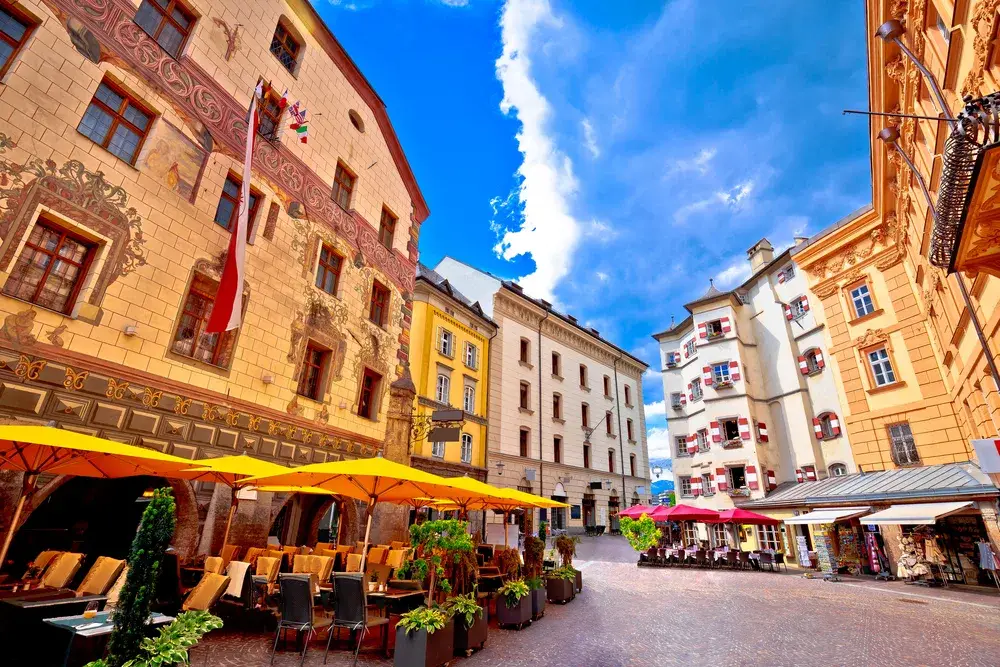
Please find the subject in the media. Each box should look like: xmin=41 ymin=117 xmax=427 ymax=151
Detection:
xmin=205 ymin=82 xmax=264 ymax=334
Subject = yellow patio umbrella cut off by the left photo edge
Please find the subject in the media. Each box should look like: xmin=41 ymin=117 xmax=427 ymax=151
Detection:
xmin=0 ymin=426 xmax=191 ymax=563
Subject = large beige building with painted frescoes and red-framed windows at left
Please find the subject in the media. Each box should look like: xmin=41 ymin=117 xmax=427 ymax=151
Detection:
xmin=0 ymin=0 xmax=428 ymax=554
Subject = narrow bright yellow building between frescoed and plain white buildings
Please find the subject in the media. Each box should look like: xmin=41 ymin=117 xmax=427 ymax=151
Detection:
xmin=410 ymin=264 xmax=497 ymax=481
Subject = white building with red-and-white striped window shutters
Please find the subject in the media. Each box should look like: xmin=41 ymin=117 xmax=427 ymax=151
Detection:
xmin=653 ymin=239 xmax=856 ymax=509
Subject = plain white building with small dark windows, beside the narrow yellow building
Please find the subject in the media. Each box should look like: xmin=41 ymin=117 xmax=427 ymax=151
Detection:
xmin=434 ymin=257 xmax=650 ymax=531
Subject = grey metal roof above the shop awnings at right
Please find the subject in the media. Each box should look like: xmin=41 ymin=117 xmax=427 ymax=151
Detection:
xmin=740 ymin=462 xmax=1000 ymax=509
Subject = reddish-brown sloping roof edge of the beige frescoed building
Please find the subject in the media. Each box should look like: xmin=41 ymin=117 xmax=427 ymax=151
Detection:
xmin=288 ymin=0 xmax=430 ymax=222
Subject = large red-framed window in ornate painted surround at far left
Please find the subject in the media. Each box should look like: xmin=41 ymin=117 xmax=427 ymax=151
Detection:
xmin=0 ymin=218 xmax=95 ymax=313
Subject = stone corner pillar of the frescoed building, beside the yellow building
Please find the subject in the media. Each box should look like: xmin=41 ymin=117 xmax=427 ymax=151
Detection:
xmin=368 ymin=363 xmax=417 ymax=544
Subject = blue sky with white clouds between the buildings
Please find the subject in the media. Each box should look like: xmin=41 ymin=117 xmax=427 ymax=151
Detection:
xmin=322 ymin=0 xmax=871 ymax=456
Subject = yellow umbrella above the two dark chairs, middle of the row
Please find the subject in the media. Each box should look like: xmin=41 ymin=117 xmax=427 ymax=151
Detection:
xmin=242 ymin=456 xmax=492 ymax=572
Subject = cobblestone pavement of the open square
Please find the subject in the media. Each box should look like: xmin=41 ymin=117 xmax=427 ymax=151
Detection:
xmin=192 ymin=536 xmax=1000 ymax=667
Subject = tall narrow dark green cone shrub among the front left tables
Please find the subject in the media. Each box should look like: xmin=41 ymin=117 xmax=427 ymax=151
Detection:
xmin=107 ymin=488 xmax=177 ymax=667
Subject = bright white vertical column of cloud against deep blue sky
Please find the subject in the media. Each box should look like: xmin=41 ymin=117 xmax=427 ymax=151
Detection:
xmin=494 ymin=0 xmax=581 ymax=301
